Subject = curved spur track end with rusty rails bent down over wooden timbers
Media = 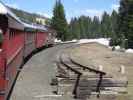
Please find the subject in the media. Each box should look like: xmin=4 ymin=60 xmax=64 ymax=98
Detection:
xmin=51 ymin=50 xmax=128 ymax=100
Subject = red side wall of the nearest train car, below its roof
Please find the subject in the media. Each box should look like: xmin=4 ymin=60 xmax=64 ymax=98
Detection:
xmin=5 ymin=29 xmax=24 ymax=98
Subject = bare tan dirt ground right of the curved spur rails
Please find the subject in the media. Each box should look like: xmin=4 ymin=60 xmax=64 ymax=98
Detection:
xmin=71 ymin=43 xmax=133 ymax=100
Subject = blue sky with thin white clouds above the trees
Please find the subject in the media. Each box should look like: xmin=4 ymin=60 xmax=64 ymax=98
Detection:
xmin=2 ymin=0 xmax=119 ymax=22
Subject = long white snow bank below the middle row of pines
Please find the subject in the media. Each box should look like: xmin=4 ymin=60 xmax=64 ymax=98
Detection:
xmin=78 ymin=38 xmax=109 ymax=46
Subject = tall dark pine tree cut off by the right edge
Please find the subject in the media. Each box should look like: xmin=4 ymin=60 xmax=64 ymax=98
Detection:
xmin=118 ymin=0 xmax=133 ymax=48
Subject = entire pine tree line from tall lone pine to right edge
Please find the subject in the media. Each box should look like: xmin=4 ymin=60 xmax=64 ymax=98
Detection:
xmin=50 ymin=0 xmax=133 ymax=48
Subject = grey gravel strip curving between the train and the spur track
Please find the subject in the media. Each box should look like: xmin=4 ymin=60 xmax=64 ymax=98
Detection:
xmin=10 ymin=44 xmax=73 ymax=100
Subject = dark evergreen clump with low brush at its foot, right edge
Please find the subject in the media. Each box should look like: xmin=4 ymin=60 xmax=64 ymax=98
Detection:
xmin=116 ymin=0 xmax=133 ymax=48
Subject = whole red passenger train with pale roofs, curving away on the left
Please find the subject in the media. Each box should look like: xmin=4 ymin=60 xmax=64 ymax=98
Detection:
xmin=0 ymin=3 xmax=55 ymax=100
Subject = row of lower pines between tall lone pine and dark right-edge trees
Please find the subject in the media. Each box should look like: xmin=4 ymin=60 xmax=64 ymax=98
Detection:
xmin=69 ymin=10 xmax=118 ymax=39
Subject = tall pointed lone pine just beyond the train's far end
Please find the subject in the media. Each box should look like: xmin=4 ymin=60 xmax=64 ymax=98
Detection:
xmin=51 ymin=0 xmax=68 ymax=41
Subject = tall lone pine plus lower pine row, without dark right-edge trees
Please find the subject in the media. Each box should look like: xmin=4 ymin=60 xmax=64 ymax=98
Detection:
xmin=51 ymin=0 xmax=118 ymax=40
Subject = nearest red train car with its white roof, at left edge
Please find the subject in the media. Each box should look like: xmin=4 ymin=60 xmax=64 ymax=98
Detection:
xmin=0 ymin=3 xmax=24 ymax=100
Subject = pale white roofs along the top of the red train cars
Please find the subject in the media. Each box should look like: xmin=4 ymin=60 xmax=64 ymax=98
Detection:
xmin=0 ymin=2 xmax=47 ymax=32
